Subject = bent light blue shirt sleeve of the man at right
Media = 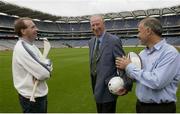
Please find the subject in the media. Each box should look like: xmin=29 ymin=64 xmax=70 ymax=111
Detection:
xmin=126 ymin=50 xmax=180 ymax=89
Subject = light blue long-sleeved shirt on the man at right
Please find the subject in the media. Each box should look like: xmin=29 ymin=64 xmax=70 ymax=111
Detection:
xmin=126 ymin=40 xmax=180 ymax=103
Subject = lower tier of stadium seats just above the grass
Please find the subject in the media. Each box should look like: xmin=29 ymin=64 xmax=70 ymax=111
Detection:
xmin=0 ymin=37 xmax=180 ymax=50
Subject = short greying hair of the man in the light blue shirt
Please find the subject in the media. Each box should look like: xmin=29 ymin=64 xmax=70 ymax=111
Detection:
xmin=140 ymin=17 xmax=163 ymax=36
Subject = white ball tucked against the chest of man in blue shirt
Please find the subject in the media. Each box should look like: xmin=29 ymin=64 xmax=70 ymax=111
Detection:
xmin=128 ymin=52 xmax=142 ymax=69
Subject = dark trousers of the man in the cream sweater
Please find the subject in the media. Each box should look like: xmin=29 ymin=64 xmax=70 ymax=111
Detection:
xmin=19 ymin=95 xmax=47 ymax=113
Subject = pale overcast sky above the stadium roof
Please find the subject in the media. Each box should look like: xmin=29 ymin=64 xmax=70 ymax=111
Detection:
xmin=2 ymin=0 xmax=180 ymax=16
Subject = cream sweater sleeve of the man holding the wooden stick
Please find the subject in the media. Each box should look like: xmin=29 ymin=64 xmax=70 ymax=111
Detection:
xmin=16 ymin=42 xmax=50 ymax=80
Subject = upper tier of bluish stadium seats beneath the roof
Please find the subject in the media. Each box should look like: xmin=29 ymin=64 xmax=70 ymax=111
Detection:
xmin=0 ymin=15 xmax=180 ymax=31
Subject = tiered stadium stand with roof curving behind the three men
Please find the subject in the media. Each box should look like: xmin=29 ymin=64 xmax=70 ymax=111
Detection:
xmin=0 ymin=1 xmax=180 ymax=49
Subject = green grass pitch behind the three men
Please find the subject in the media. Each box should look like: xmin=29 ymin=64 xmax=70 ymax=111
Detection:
xmin=0 ymin=48 xmax=180 ymax=113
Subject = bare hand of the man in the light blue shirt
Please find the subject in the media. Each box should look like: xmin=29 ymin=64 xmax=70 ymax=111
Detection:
xmin=116 ymin=56 xmax=131 ymax=70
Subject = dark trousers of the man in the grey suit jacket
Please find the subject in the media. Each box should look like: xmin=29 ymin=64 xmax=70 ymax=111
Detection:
xmin=96 ymin=101 xmax=116 ymax=113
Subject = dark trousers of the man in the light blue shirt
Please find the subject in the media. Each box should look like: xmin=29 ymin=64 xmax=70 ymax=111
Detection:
xmin=136 ymin=100 xmax=176 ymax=113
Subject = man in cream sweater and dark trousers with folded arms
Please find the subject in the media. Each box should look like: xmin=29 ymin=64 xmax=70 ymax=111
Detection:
xmin=12 ymin=18 xmax=51 ymax=113
